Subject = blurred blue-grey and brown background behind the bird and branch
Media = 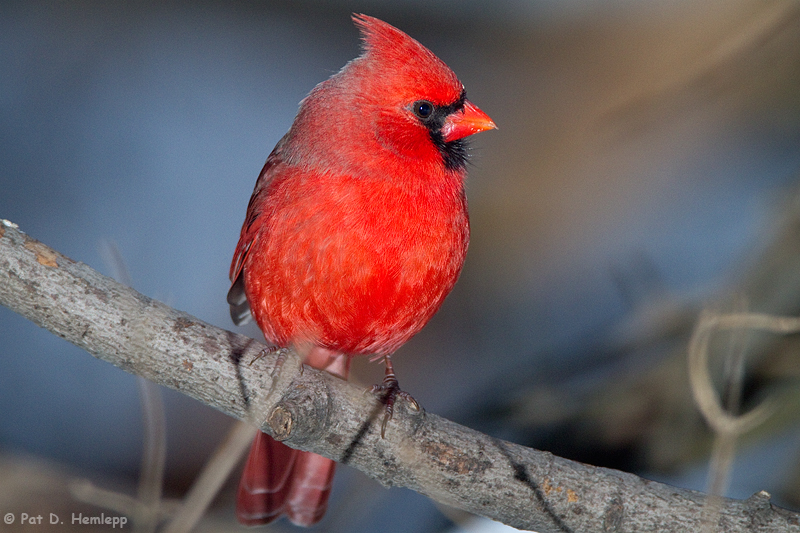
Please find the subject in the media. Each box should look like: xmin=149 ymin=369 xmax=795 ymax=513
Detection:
xmin=0 ymin=0 xmax=800 ymax=532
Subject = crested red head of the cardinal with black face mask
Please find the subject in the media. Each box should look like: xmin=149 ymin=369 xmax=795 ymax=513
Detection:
xmin=282 ymin=15 xmax=495 ymax=177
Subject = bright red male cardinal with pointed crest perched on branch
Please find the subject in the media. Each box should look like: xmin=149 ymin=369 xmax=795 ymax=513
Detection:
xmin=228 ymin=15 xmax=495 ymax=526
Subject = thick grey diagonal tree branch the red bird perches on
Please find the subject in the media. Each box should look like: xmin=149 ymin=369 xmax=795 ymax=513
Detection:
xmin=0 ymin=221 xmax=800 ymax=533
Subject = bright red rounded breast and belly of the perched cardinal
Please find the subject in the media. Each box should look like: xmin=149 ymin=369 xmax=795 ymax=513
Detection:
xmin=245 ymin=168 xmax=469 ymax=354
